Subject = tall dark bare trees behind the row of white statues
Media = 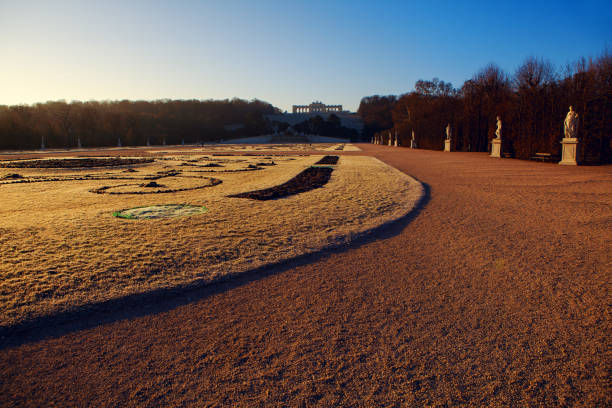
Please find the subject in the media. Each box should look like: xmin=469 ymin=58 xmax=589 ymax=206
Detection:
xmin=359 ymin=52 xmax=612 ymax=164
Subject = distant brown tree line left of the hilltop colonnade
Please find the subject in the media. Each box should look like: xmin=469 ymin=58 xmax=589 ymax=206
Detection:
xmin=0 ymin=99 xmax=278 ymax=149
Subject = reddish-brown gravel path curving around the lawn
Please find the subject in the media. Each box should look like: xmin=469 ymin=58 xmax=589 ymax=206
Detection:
xmin=0 ymin=145 xmax=612 ymax=407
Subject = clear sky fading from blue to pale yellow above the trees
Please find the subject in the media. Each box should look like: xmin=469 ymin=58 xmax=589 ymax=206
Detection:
xmin=0 ymin=0 xmax=612 ymax=110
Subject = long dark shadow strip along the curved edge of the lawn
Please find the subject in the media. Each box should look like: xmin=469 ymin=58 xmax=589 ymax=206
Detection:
xmin=0 ymin=176 xmax=431 ymax=350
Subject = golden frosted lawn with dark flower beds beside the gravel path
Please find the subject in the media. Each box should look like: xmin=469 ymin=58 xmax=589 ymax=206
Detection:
xmin=0 ymin=154 xmax=422 ymax=327
